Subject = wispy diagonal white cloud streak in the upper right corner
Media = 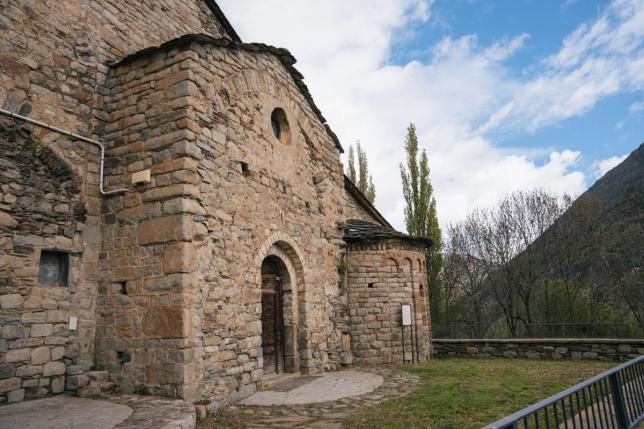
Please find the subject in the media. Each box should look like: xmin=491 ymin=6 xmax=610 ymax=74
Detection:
xmin=481 ymin=0 xmax=644 ymax=132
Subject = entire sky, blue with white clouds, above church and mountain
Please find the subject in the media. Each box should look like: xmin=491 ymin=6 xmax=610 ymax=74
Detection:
xmin=219 ymin=0 xmax=644 ymax=229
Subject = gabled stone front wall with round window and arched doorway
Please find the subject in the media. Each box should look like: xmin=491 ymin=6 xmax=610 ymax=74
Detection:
xmin=185 ymin=39 xmax=344 ymax=400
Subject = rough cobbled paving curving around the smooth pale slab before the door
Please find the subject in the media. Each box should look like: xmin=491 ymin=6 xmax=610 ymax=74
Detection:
xmin=197 ymin=368 xmax=418 ymax=429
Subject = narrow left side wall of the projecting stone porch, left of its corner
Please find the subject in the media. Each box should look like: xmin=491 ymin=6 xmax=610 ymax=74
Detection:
xmin=96 ymin=52 xmax=206 ymax=400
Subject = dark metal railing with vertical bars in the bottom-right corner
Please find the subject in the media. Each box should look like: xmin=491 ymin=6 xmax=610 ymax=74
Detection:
xmin=483 ymin=356 xmax=644 ymax=429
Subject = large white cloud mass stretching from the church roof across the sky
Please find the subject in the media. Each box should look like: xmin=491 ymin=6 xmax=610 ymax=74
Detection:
xmin=219 ymin=0 xmax=644 ymax=228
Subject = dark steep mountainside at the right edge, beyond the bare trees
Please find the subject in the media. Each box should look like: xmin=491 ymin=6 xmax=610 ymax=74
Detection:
xmin=531 ymin=144 xmax=644 ymax=335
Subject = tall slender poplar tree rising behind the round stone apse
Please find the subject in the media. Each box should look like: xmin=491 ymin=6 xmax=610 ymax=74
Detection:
xmin=400 ymin=124 xmax=443 ymax=319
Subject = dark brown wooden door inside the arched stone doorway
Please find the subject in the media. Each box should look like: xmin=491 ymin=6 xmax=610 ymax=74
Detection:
xmin=262 ymin=255 xmax=290 ymax=374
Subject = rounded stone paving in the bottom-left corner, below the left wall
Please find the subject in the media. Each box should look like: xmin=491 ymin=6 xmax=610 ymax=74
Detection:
xmin=0 ymin=395 xmax=195 ymax=429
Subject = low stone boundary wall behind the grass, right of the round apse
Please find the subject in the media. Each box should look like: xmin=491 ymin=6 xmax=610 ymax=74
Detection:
xmin=432 ymin=338 xmax=644 ymax=361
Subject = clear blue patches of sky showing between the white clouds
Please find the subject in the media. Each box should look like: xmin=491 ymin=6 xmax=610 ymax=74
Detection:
xmin=388 ymin=0 xmax=644 ymax=175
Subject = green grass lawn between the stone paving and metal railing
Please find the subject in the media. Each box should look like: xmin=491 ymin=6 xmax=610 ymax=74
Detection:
xmin=345 ymin=359 xmax=617 ymax=429
